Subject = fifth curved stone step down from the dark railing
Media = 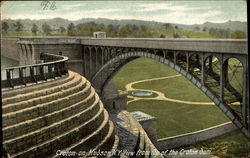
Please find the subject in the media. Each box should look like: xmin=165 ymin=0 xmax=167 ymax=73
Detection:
xmin=3 ymin=88 xmax=95 ymax=140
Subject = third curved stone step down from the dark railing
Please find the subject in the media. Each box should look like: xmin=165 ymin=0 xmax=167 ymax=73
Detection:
xmin=2 ymin=75 xmax=86 ymax=115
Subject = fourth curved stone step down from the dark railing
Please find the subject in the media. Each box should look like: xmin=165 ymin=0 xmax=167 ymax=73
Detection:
xmin=2 ymin=78 xmax=91 ymax=127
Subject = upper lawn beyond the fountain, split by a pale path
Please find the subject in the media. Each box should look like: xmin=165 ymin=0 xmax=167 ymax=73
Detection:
xmin=114 ymin=58 xmax=210 ymax=102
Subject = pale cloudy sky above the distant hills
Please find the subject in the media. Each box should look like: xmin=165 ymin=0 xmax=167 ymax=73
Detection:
xmin=1 ymin=0 xmax=247 ymax=24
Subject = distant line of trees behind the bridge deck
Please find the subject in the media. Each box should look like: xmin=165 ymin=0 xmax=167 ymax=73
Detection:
xmin=1 ymin=21 xmax=246 ymax=39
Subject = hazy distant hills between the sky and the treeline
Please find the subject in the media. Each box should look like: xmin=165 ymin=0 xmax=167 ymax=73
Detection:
xmin=2 ymin=18 xmax=247 ymax=32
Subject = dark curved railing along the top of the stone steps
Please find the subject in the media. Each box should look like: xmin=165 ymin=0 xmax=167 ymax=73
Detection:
xmin=1 ymin=53 xmax=68 ymax=88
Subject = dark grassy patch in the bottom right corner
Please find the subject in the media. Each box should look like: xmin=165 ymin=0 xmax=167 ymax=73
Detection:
xmin=195 ymin=130 xmax=250 ymax=158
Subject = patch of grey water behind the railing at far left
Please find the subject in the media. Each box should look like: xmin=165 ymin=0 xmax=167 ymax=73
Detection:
xmin=1 ymin=56 xmax=19 ymax=80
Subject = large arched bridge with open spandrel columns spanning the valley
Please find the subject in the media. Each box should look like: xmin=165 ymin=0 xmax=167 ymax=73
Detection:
xmin=3 ymin=38 xmax=250 ymax=138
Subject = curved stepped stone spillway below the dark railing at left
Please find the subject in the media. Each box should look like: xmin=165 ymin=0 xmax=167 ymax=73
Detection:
xmin=2 ymin=72 xmax=116 ymax=158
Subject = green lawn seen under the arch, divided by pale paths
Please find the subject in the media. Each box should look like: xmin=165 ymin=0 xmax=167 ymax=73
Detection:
xmin=114 ymin=58 xmax=228 ymax=138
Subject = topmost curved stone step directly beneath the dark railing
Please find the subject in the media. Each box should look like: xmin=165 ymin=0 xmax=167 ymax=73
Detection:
xmin=2 ymin=71 xmax=71 ymax=98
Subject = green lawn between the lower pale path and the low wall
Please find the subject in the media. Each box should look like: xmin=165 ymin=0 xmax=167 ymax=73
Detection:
xmin=127 ymin=100 xmax=228 ymax=138
